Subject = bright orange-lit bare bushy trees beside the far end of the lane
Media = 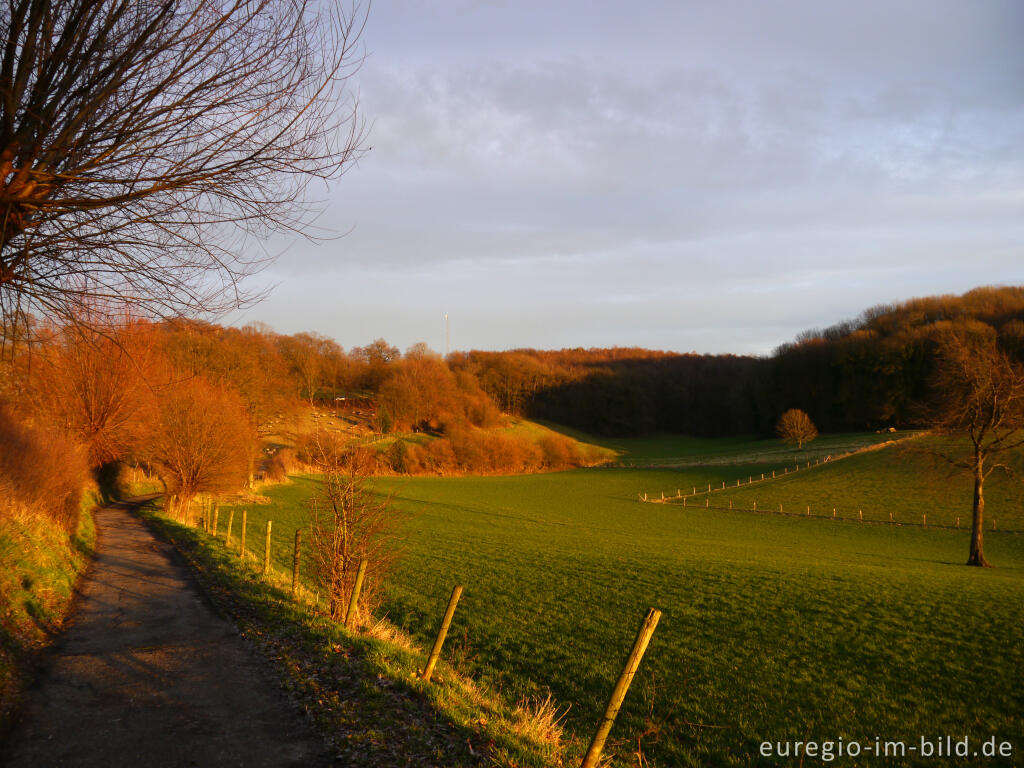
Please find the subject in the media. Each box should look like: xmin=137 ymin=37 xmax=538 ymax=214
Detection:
xmin=2 ymin=323 xmax=257 ymax=514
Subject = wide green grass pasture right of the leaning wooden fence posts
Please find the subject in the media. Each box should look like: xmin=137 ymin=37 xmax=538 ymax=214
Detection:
xmin=234 ymin=435 xmax=1024 ymax=766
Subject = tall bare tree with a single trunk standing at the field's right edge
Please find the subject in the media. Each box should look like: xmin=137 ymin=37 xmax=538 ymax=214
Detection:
xmin=932 ymin=336 xmax=1024 ymax=567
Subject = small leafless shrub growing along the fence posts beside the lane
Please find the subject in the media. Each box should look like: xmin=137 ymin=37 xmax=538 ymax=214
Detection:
xmin=309 ymin=445 xmax=395 ymax=620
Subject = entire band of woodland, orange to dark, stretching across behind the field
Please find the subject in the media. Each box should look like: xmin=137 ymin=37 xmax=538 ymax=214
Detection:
xmin=0 ymin=288 xmax=1024 ymax=532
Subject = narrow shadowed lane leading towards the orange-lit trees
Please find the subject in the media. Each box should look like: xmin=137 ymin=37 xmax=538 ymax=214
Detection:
xmin=0 ymin=507 xmax=331 ymax=768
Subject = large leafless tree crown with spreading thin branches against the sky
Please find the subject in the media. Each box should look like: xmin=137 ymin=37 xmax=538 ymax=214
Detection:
xmin=0 ymin=0 xmax=366 ymax=318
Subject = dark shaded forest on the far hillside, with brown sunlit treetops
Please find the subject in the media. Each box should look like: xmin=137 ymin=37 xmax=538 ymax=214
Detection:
xmin=450 ymin=288 xmax=1024 ymax=436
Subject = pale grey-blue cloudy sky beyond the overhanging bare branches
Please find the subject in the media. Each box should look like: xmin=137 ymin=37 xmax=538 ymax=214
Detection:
xmin=230 ymin=0 xmax=1024 ymax=354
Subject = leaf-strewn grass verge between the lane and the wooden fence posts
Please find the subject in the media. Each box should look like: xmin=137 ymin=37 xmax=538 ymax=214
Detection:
xmin=140 ymin=509 xmax=520 ymax=766
